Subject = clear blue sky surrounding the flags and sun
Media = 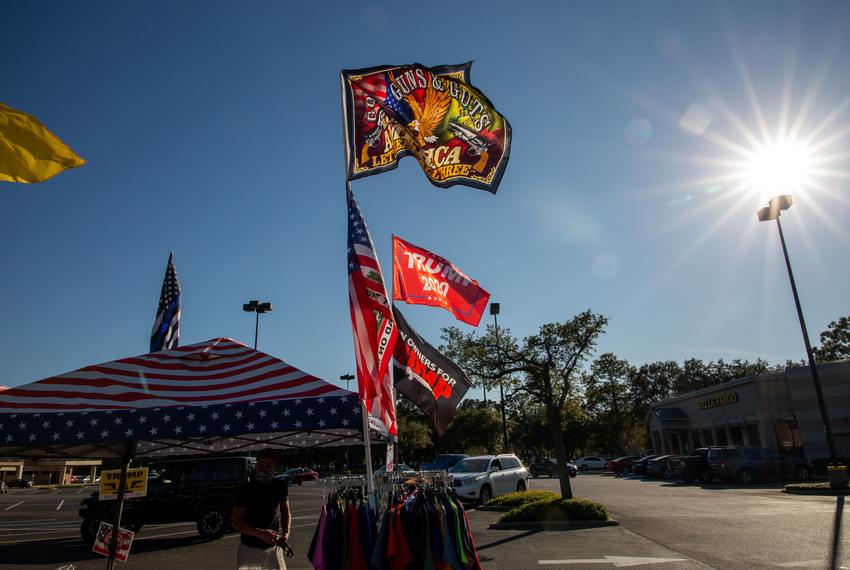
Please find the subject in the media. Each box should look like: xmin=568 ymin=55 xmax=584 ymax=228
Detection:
xmin=0 ymin=1 xmax=850 ymax=394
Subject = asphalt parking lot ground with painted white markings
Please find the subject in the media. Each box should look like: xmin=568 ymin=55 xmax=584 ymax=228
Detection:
xmin=0 ymin=473 xmax=850 ymax=570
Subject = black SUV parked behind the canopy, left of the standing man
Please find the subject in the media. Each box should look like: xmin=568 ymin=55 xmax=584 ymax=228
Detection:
xmin=79 ymin=457 xmax=257 ymax=543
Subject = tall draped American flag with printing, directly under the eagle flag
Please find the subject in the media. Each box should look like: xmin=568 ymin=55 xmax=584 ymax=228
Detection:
xmin=346 ymin=187 xmax=398 ymax=406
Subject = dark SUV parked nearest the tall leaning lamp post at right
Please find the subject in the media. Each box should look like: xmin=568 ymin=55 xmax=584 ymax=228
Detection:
xmin=708 ymin=445 xmax=812 ymax=485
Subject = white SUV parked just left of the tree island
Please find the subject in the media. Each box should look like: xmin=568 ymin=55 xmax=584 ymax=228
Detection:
xmin=451 ymin=454 xmax=528 ymax=503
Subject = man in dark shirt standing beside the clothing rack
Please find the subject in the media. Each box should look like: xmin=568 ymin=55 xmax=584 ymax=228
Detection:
xmin=233 ymin=449 xmax=292 ymax=570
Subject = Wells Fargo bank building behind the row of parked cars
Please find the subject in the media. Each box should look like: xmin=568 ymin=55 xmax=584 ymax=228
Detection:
xmin=647 ymin=360 xmax=850 ymax=459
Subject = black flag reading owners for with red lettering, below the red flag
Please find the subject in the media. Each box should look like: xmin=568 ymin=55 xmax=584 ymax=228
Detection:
xmin=393 ymin=306 xmax=471 ymax=435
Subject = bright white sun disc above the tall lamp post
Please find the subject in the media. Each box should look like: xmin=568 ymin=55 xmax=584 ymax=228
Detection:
xmin=744 ymin=139 xmax=812 ymax=196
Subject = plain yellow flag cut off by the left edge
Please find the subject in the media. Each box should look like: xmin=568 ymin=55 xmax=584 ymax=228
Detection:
xmin=0 ymin=103 xmax=86 ymax=182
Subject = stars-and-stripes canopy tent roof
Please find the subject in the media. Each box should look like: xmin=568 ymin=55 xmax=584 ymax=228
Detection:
xmin=0 ymin=338 xmax=362 ymax=457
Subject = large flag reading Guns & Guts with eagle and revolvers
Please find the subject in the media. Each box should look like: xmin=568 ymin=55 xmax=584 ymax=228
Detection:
xmin=341 ymin=62 xmax=511 ymax=194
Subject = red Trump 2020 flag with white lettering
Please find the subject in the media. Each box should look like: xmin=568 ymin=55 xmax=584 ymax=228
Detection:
xmin=393 ymin=236 xmax=490 ymax=327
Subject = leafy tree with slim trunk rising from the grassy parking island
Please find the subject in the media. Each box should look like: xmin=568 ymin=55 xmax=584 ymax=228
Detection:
xmin=443 ymin=311 xmax=608 ymax=498
